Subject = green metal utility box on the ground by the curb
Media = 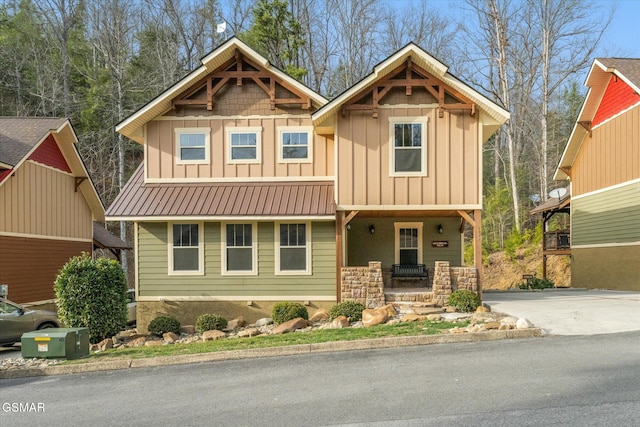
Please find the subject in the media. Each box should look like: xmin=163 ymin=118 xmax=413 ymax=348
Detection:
xmin=21 ymin=328 xmax=89 ymax=359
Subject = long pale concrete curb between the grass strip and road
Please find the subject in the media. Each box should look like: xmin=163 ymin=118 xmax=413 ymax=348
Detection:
xmin=0 ymin=328 xmax=542 ymax=379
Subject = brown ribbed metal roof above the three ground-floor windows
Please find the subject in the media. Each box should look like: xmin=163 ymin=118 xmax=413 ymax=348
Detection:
xmin=106 ymin=164 xmax=335 ymax=220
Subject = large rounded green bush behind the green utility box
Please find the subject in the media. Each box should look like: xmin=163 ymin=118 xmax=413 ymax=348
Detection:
xmin=53 ymin=253 xmax=127 ymax=344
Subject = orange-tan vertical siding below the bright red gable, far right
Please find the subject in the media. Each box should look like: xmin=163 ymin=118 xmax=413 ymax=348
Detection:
xmin=571 ymin=107 xmax=640 ymax=196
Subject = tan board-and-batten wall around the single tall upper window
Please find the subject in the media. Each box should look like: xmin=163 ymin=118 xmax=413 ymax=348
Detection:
xmin=337 ymin=105 xmax=481 ymax=207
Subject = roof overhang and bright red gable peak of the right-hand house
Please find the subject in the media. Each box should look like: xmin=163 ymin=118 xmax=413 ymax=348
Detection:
xmin=553 ymin=58 xmax=640 ymax=180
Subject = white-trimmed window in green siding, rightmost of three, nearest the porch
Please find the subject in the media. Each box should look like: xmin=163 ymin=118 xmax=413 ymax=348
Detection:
xmin=275 ymin=222 xmax=311 ymax=275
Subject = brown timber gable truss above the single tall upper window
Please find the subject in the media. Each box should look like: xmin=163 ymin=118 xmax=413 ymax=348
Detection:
xmin=342 ymin=57 xmax=476 ymax=118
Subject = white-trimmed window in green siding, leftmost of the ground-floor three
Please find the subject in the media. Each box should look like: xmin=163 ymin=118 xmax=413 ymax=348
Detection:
xmin=168 ymin=223 xmax=204 ymax=275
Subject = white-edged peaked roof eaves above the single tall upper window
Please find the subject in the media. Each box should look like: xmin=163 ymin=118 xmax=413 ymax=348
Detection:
xmin=312 ymin=43 xmax=509 ymax=141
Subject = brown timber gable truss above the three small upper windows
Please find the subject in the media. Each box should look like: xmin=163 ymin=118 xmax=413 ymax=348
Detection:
xmin=172 ymin=49 xmax=311 ymax=111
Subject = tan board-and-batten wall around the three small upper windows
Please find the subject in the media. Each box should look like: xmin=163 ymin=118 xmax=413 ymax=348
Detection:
xmin=145 ymin=116 xmax=333 ymax=180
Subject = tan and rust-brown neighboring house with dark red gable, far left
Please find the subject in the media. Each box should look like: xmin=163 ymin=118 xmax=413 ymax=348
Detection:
xmin=0 ymin=117 xmax=104 ymax=303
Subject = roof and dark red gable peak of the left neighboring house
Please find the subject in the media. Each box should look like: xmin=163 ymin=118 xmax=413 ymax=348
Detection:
xmin=0 ymin=117 xmax=104 ymax=221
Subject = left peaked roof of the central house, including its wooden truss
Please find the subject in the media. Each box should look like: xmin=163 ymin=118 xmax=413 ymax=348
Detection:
xmin=116 ymin=37 xmax=327 ymax=144
